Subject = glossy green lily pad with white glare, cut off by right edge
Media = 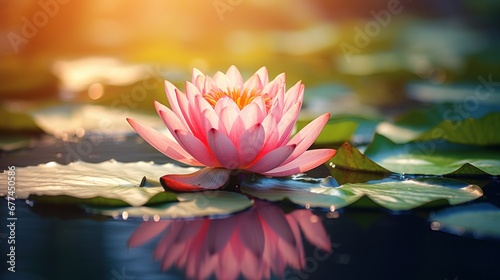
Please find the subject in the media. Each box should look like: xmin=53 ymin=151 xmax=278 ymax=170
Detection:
xmin=364 ymin=135 xmax=500 ymax=175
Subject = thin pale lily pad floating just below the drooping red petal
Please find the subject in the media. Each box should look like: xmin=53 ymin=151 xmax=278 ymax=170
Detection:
xmin=87 ymin=191 xmax=253 ymax=220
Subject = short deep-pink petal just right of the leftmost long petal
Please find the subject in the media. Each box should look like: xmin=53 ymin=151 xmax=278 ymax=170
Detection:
xmin=174 ymin=130 xmax=220 ymax=167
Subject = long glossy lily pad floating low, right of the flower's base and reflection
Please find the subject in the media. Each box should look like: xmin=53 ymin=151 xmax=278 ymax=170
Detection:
xmin=241 ymin=177 xmax=483 ymax=211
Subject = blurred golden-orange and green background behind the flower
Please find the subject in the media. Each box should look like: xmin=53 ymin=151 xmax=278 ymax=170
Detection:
xmin=0 ymin=0 xmax=500 ymax=136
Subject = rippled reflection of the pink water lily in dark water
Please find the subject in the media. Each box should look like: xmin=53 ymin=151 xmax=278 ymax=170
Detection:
xmin=128 ymin=201 xmax=331 ymax=279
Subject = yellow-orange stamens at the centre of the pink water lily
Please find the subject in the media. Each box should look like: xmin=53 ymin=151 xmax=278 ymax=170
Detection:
xmin=203 ymin=88 xmax=271 ymax=110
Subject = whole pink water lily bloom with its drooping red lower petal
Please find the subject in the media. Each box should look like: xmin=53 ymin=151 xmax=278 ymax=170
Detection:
xmin=127 ymin=66 xmax=336 ymax=191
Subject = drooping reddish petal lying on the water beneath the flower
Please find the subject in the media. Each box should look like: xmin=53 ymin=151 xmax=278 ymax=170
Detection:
xmin=160 ymin=167 xmax=231 ymax=192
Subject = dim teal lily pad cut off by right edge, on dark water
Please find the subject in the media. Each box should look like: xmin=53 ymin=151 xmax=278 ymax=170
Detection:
xmin=430 ymin=203 xmax=500 ymax=238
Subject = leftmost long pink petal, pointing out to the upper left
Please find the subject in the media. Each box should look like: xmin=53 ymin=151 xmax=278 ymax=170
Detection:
xmin=127 ymin=119 xmax=203 ymax=166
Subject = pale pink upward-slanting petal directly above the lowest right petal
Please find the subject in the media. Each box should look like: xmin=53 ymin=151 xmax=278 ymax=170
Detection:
xmin=283 ymin=113 xmax=330 ymax=165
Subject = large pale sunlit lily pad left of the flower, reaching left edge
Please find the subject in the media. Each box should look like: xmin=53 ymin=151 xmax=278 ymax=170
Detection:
xmin=0 ymin=160 xmax=197 ymax=206
